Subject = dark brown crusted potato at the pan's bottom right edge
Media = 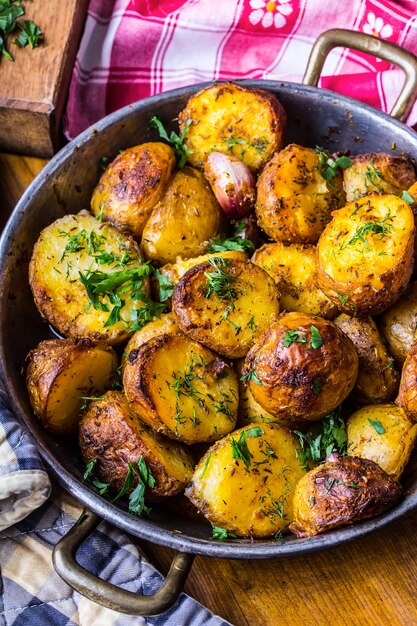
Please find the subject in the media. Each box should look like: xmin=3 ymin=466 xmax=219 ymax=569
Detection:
xmin=290 ymin=456 xmax=402 ymax=537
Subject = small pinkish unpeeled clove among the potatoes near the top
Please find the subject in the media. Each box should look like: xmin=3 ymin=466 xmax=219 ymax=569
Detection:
xmin=204 ymin=152 xmax=256 ymax=220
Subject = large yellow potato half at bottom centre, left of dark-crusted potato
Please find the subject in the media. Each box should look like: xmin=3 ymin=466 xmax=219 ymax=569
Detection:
xmin=185 ymin=424 xmax=305 ymax=537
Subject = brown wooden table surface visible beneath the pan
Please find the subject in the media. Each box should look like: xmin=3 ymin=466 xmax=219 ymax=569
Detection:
xmin=0 ymin=155 xmax=417 ymax=626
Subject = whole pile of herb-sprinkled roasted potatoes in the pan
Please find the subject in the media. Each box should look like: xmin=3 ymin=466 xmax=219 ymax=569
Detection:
xmin=27 ymin=83 xmax=417 ymax=540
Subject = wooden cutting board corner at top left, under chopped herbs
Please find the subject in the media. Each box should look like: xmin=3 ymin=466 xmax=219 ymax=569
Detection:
xmin=0 ymin=0 xmax=88 ymax=157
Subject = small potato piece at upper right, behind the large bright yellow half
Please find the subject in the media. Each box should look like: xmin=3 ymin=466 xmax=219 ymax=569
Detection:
xmin=343 ymin=152 xmax=416 ymax=202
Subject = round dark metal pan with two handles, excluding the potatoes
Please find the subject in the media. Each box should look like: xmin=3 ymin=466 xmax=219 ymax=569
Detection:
xmin=0 ymin=30 xmax=417 ymax=615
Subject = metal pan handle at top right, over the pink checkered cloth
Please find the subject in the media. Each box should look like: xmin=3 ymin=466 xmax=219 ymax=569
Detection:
xmin=303 ymin=28 xmax=417 ymax=120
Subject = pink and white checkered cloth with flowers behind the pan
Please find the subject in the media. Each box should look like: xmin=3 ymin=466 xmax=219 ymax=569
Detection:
xmin=65 ymin=0 xmax=417 ymax=138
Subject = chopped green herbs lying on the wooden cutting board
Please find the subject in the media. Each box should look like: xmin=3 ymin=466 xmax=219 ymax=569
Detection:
xmin=0 ymin=0 xmax=43 ymax=61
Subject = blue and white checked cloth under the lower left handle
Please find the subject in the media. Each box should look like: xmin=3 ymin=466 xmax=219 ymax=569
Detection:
xmin=0 ymin=392 xmax=230 ymax=626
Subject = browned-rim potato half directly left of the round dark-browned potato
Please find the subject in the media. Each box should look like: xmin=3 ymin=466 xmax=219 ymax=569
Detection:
xmin=123 ymin=334 xmax=238 ymax=443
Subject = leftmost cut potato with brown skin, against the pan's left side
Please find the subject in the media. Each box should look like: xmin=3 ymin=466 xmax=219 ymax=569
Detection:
xmin=26 ymin=339 xmax=118 ymax=435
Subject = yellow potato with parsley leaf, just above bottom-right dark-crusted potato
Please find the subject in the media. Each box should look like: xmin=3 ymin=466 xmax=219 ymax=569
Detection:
xmin=346 ymin=404 xmax=417 ymax=480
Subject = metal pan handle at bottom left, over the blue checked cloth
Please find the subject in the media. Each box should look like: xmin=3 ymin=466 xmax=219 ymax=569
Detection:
xmin=52 ymin=509 xmax=194 ymax=616
